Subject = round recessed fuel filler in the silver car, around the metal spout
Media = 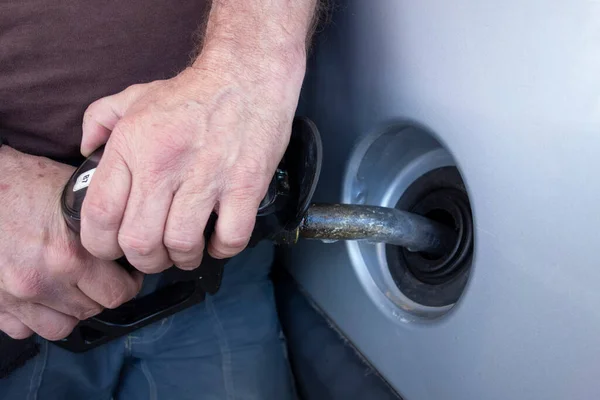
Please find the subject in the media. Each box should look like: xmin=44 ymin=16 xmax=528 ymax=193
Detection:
xmin=342 ymin=121 xmax=476 ymax=323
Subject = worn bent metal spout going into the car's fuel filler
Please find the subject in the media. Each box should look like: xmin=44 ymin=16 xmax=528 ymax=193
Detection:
xmin=300 ymin=204 xmax=457 ymax=256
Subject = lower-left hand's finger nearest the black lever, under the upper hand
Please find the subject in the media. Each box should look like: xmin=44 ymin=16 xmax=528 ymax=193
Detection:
xmin=77 ymin=261 xmax=144 ymax=309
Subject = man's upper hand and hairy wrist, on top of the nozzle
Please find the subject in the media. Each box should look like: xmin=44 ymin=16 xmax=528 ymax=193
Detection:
xmin=81 ymin=0 xmax=322 ymax=273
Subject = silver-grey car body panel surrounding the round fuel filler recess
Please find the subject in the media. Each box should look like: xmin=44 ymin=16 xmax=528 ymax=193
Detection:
xmin=289 ymin=0 xmax=600 ymax=400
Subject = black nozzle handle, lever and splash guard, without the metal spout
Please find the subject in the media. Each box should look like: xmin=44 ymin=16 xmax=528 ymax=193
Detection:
xmin=55 ymin=117 xmax=323 ymax=352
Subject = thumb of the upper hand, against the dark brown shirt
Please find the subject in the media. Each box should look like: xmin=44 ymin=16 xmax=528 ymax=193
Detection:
xmin=81 ymin=85 xmax=143 ymax=157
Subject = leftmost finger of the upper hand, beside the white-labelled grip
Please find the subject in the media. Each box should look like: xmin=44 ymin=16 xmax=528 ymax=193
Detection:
xmin=81 ymin=142 xmax=131 ymax=260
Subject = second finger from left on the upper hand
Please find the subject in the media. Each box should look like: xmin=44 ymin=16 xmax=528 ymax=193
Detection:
xmin=118 ymin=179 xmax=173 ymax=274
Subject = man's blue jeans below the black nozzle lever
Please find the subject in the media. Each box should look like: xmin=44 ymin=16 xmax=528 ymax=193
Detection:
xmin=0 ymin=243 xmax=295 ymax=400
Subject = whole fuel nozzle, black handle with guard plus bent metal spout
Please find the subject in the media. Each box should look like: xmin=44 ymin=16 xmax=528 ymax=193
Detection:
xmin=57 ymin=118 xmax=456 ymax=352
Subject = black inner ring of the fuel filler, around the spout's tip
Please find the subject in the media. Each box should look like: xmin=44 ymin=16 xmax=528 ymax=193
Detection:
xmin=386 ymin=166 xmax=473 ymax=307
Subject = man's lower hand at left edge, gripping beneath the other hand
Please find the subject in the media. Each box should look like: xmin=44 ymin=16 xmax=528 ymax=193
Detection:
xmin=0 ymin=146 xmax=142 ymax=340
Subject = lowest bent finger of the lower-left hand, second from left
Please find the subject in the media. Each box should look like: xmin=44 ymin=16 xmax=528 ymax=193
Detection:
xmin=11 ymin=302 xmax=79 ymax=340
